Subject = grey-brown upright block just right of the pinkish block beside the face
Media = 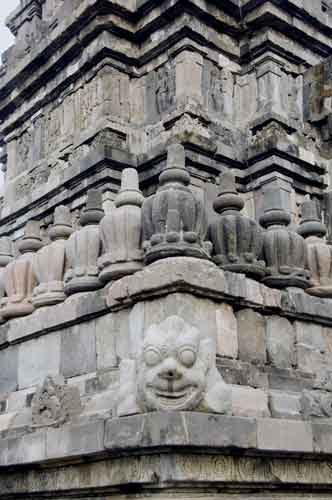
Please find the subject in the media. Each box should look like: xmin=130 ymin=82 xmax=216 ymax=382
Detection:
xmin=236 ymin=309 xmax=266 ymax=363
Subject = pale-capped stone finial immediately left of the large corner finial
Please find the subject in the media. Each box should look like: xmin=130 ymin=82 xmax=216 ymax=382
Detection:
xmin=98 ymin=168 xmax=144 ymax=283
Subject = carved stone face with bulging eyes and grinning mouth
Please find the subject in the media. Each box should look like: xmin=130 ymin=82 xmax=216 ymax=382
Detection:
xmin=138 ymin=316 xmax=209 ymax=411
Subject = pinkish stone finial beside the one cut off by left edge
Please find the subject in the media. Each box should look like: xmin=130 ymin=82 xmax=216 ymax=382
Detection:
xmin=1 ymin=221 xmax=42 ymax=319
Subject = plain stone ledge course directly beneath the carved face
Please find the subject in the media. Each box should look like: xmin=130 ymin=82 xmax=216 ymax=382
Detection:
xmin=0 ymin=412 xmax=332 ymax=474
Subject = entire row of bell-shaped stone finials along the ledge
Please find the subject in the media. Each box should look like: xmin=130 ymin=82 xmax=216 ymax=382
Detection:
xmin=0 ymin=145 xmax=332 ymax=319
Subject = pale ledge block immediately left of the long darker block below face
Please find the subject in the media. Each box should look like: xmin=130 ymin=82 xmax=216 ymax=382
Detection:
xmin=46 ymin=420 xmax=105 ymax=459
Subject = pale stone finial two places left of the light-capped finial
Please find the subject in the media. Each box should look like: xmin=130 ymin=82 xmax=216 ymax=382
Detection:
xmin=32 ymin=206 xmax=73 ymax=307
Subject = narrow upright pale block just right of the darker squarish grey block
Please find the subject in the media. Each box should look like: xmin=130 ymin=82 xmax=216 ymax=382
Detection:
xmin=95 ymin=314 xmax=117 ymax=370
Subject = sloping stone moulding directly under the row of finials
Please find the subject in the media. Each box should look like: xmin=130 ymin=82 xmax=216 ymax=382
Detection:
xmin=0 ymin=257 xmax=332 ymax=346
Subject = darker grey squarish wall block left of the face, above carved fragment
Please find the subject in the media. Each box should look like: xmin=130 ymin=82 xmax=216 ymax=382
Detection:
xmin=61 ymin=321 xmax=97 ymax=377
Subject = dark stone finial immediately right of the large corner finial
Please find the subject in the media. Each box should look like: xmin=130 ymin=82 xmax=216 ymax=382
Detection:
xmin=209 ymin=170 xmax=265 ymax=279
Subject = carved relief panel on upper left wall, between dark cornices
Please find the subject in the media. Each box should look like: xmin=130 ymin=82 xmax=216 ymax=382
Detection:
xmin=8 ymin=66 xmax=129 ymax=178
